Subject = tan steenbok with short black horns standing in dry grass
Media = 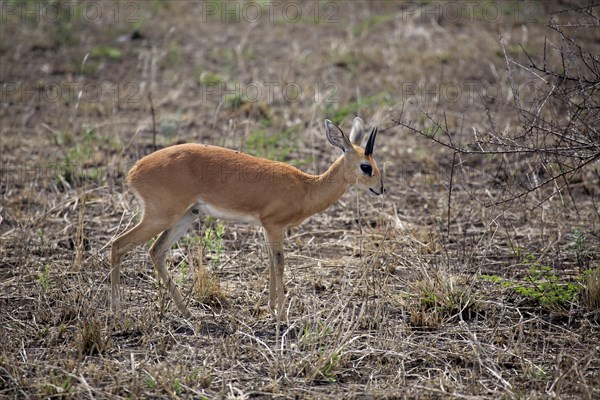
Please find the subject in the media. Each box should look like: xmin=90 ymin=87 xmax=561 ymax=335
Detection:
xmin=111 ymin=117 xmax=384 ymax=320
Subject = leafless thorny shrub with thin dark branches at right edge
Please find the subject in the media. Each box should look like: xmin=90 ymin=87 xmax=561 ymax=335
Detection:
xmin=395 ymin=3 xmax=600 ymax=209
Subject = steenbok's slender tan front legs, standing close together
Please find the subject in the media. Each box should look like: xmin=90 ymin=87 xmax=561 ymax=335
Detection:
xmin=264 ymin=227 xmax=287 ymax=322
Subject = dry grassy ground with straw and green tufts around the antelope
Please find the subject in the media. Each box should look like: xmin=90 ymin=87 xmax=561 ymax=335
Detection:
xmin=0 ymin=0 xmax=600 ymax=399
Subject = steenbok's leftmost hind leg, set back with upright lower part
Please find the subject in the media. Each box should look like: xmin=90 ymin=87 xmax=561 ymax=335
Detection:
xmin=110 ymin=217 xmax=168 ymax=312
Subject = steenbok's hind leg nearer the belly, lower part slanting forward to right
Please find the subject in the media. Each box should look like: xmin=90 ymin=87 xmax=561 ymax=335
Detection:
xmin=150 ymin=207 xmax=199 ymax=318
